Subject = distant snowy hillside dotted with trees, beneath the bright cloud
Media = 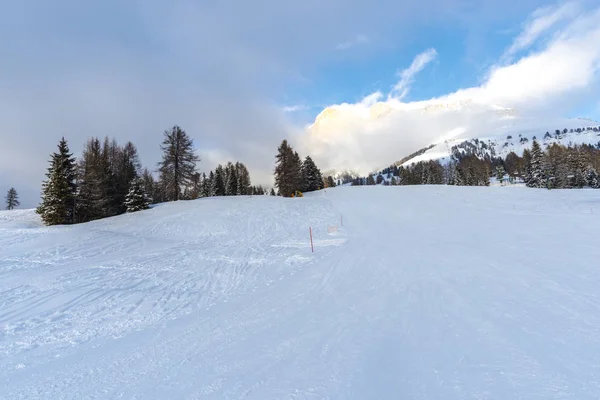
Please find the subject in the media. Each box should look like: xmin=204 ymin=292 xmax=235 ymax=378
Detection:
xmin=398 ymin=118 xmax=600 ymax=166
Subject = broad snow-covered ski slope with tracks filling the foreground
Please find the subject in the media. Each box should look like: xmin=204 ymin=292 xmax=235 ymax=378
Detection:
xmin=0 ymin=186 xmax=600 ymax=400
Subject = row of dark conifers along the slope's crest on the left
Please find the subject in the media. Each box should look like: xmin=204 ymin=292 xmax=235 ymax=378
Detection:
xmin=35 ymin=125 xmax=266 ymax=225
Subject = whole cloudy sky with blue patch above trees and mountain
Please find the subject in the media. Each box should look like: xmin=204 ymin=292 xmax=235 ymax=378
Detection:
xmin=0 ymin=0 xmax=600 ymax=207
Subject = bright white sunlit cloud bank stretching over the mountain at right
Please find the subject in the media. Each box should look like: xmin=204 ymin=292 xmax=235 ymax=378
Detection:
xmin=300 ymin=1 xmax=600 ymax=173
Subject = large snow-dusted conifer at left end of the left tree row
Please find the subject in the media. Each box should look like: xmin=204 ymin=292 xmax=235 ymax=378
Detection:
xmin=36 ymin=137 xmax=76 ymax=225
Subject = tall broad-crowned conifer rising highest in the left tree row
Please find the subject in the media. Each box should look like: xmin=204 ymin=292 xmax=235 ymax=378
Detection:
xmin=158 ymin=125 xmax=200 ymax=201
